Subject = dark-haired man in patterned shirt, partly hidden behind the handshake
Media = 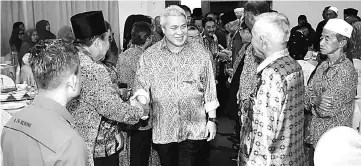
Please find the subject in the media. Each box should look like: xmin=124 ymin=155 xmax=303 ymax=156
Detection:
xmin=117 ymin=21 xmax=153 ymax=166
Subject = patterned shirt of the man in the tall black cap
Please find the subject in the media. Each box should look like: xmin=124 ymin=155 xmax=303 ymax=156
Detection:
xmin=67 ymin=47 xmax=143 ymax=166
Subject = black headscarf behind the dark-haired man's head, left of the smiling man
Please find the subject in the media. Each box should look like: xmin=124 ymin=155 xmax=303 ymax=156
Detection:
xmin=123 ymin=14 xmax=152 ymax=51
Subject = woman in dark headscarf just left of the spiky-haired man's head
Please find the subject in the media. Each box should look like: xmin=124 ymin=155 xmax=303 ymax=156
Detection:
xmin=18 ymin=29 xmax=39 ymax=67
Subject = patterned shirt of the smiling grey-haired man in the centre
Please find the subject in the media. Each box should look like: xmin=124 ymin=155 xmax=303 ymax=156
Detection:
xmin=135 ymin=38 xmax=219 ymax=144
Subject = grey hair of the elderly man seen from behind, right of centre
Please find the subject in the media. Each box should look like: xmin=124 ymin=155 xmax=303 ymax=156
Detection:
xmin=252 ymin=12 xmax=290 ymax=44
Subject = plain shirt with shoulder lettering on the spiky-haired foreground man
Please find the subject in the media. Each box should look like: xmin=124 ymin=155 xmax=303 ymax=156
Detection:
xmin=1 ymin=95 xmax=88 ymax=166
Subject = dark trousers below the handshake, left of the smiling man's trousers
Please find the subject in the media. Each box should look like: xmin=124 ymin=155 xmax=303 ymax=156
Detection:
xmin=130 ymin=129 xmax=152 ymax=166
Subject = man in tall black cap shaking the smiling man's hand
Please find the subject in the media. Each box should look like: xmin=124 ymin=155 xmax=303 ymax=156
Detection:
xmin=68 ymin=11 xmax=148 ymax=166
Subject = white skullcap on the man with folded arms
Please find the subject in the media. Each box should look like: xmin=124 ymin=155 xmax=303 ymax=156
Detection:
xmin=323 ymin=18 xmax=353 ymax=38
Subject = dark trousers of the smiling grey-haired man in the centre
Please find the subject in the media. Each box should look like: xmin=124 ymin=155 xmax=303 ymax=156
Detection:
xmin=157 ymin=140 xmax=206 ymax=166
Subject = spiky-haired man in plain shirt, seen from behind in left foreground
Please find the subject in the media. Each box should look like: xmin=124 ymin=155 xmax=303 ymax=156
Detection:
xmin=1 ymin=40 xmax=88 ymax=166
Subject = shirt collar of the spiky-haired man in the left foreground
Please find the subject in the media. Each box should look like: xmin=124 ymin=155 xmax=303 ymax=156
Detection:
xmin=32 ymin=95 xmax=74 ymax=125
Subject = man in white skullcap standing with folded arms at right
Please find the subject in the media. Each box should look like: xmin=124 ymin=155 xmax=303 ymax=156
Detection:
xmin=305 ymin=19 xmax=357 ymax=160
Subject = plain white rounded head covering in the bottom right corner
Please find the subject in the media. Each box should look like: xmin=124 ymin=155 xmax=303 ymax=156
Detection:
xmin=314 ymin=126 xmax=361 ymax=166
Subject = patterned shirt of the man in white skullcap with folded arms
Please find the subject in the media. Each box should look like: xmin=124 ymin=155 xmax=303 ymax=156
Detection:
xmin=305 ymin=55 xmax=358 ymax=146
